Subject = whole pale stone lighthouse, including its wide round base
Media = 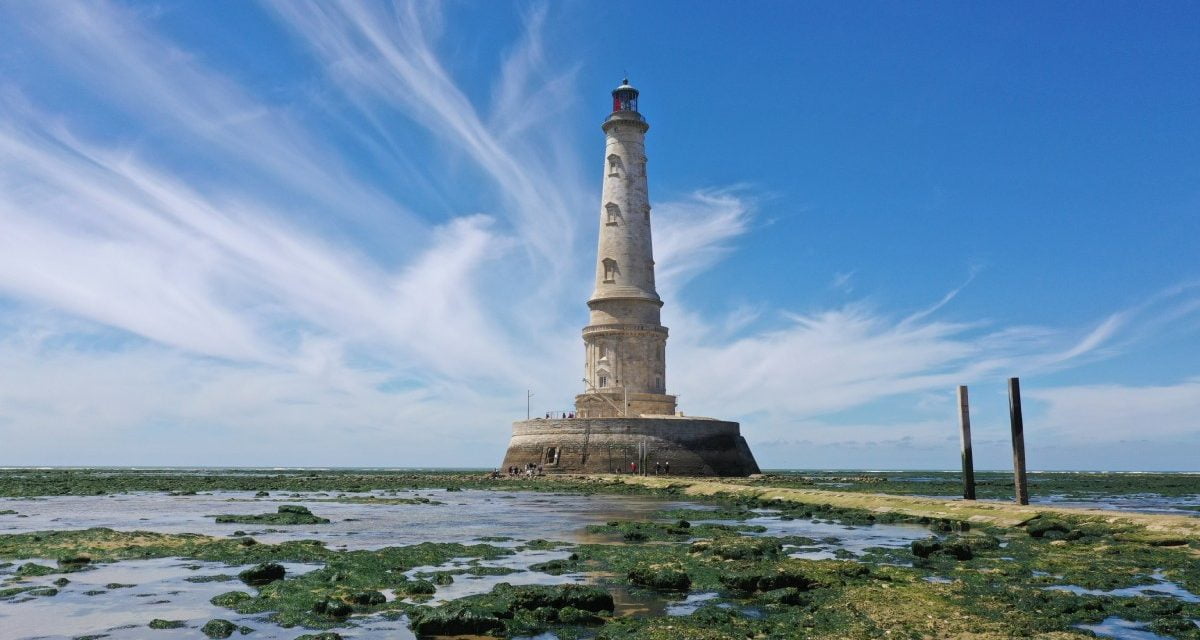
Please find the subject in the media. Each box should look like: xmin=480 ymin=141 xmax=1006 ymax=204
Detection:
xmin=500 ymin=79 xmax=758 ymax=475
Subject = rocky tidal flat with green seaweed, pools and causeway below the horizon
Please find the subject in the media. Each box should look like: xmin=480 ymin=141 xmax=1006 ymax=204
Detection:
xmin=0 ymin=468 xmax=1200 ymax=640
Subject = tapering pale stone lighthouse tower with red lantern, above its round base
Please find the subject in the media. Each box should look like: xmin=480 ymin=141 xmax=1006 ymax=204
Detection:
xmin=575 ymin=79 xmax=676 ymax=418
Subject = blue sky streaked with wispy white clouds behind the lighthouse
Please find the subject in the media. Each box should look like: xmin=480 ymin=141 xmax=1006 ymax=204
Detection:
xmin=0 ymin=1 xmax=1200 ymax=469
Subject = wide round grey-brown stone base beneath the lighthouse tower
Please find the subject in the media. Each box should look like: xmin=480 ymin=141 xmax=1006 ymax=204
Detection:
xmin=500 ymin=415 xmax=758 ymax=475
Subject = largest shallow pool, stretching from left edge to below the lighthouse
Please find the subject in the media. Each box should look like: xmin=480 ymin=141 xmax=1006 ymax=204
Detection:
xmin=0 ymin=490 xmax=698 ymax=549
